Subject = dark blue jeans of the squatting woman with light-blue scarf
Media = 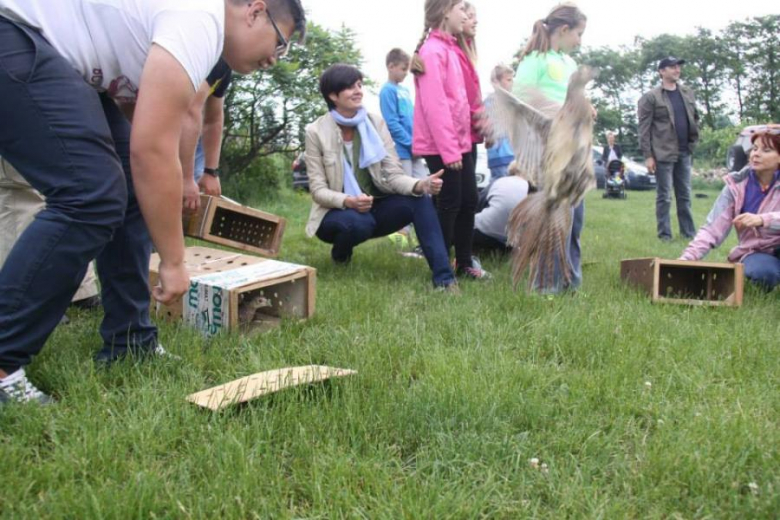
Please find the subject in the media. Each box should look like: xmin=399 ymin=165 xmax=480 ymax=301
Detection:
xmin=317 ymin=195 xmax=455 ymax=286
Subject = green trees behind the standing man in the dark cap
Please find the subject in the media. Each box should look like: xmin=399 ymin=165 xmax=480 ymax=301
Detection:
xmin=577 ymin=15 xmax=780 ymax=165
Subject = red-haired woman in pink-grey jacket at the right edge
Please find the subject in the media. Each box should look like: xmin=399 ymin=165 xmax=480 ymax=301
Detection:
xmin=680 ymin=129 xmax=780 ymax=291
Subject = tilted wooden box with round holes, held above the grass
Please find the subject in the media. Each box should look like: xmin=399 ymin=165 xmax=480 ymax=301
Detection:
xmin=184 ymin=195 xmax=286 ymax=258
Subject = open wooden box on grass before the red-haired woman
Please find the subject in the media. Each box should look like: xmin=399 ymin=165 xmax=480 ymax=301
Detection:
xmin=620 ymin=258 xmax=745 ymax=307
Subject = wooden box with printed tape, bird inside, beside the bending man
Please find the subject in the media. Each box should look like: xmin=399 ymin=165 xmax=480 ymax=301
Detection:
xmin=149 ymin=247 xmax=317 ymax=336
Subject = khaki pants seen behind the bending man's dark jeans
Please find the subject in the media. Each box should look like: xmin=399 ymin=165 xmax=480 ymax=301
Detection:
xmin=0 ymin=157 xmax=100 ymax=302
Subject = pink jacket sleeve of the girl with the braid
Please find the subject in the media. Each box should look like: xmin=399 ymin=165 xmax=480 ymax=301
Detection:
xmin=416 ymin=52 xmax=463 ymax=164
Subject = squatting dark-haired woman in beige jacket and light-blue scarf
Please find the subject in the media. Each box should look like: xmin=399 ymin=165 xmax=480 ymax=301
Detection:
xmin=305 ymin=64 xmax=455 ymax=289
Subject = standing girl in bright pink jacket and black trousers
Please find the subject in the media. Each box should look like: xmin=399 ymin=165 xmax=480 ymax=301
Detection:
xmin=411 ymin=0 xmax=489 ymax=280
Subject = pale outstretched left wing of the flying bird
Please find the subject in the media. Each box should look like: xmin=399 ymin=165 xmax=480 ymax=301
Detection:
xmin=488 ymin=88 xmax=560 ymax=187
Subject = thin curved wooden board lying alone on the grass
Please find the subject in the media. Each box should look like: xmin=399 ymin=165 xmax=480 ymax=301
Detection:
xmin=187 ymin=365 xmax=357 ymax=411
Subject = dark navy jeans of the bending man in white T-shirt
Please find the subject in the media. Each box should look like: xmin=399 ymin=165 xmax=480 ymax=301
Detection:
xmin=0 ymin=17 xmax=157 ymax=373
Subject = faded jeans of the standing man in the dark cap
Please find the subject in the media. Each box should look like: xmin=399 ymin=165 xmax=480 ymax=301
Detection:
xmin=655 ymin=153 xmax=696 ymax=239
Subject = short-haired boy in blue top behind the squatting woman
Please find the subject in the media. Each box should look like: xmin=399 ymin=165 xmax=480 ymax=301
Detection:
xmin=379 ymin=49 xmax=428 ymax=179
